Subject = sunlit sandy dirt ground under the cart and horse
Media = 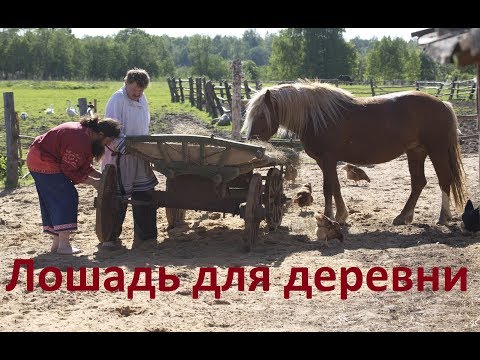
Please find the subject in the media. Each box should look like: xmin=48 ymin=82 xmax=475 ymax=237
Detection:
xmin=0 ymin=117 xmax=480 ymax=332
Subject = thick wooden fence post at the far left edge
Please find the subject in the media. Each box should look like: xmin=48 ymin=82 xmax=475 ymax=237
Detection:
xmin=3 ymin=92 xmax=19 ymax=189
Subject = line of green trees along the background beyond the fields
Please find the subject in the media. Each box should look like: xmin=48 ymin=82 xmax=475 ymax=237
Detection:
xmin=0 ymin=28 xmax=475 ymax=81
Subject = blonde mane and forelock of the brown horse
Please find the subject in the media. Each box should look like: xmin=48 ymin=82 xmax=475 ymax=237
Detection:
xmin=242 ymin=80 xmax=362 ymax=135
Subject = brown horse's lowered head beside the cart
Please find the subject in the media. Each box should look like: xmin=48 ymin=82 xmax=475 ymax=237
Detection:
xmin=242 ymin=90 xmax=279 ymax=141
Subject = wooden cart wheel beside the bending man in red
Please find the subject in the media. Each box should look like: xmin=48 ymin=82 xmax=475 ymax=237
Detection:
xmin=93 ymin=164 xmax=120 ymax=242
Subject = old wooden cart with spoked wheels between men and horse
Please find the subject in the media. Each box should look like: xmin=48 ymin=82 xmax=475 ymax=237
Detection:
xmin=94 ymin=134 xmax=287 ymax=251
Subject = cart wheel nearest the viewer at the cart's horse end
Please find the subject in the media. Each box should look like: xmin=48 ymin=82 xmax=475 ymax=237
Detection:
xmin=243 ymin=173 xmax=265 ymax=251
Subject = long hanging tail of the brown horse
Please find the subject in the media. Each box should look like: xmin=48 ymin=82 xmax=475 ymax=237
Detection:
xmin=443 ymin=101 xmax=467 ymax=211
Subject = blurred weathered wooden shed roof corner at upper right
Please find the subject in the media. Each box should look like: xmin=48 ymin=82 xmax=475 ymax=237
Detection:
xmin=411 ymin=28 xmax=480 ymax=205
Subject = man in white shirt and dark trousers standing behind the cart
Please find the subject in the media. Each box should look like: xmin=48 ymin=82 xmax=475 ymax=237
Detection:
xmin=102 ymin=68 xmax=158 ymax=246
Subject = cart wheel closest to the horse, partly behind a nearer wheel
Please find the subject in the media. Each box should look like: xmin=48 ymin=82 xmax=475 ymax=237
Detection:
xmin=263 ymin=168 xmax=286 ymax=231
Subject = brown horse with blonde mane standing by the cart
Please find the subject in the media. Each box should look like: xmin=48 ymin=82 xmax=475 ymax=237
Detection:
xmin=241 ymin=79 xmax=466 ymax=225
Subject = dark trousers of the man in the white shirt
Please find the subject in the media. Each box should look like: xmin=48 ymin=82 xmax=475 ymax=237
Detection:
xmin=110 ymin=190 xmax=157 ymax=241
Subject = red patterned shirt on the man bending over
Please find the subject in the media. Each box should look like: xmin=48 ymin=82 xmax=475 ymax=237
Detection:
xmin=27 ymin=122 xmax=95 ymax=184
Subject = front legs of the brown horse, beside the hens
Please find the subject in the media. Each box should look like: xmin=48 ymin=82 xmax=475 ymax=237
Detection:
xmin=317 ymin=158 xmax=348 ymax=224
